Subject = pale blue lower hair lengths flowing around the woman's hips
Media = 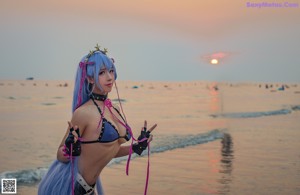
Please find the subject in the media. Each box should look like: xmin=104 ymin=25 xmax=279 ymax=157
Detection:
xmin=38 ymin=158 xmax=104 ymax=195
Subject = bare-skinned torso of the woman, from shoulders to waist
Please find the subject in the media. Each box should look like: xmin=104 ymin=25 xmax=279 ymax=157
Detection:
xmin=74 ymin=100 xmax=128 ymax=184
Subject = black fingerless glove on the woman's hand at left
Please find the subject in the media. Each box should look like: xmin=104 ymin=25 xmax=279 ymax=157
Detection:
xmin=64 ymin=127 xmax=81 ymax=156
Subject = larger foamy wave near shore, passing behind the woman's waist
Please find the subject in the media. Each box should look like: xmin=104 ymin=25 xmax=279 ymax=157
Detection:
xmin=0 ymin=129 xmax=224 ymax=186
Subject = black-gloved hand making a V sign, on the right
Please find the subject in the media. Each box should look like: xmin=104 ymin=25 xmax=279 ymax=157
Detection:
xmin=132 ymin=120 xmax=157 ymax=155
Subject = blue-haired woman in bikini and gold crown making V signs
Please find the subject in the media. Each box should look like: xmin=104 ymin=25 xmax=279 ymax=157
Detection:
xmin=38 ymin=45 xmax=157 ymax=195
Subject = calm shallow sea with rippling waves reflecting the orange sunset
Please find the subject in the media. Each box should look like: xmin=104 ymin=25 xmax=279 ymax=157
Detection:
xmin=0 ymin=80 xmax=300 ymax=195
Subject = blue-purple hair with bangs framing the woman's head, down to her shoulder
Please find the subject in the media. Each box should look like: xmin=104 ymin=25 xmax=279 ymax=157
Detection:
xmin=72 ymin=51 xmax=117 ymax=112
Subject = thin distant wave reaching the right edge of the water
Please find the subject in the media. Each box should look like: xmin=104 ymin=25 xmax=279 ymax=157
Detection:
xmin=210 ymin=105 xmax=300 ymax=118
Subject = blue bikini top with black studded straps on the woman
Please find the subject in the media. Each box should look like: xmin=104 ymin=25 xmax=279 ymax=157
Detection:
xmin=81 ymin=99 xmax=131 ymax=144
